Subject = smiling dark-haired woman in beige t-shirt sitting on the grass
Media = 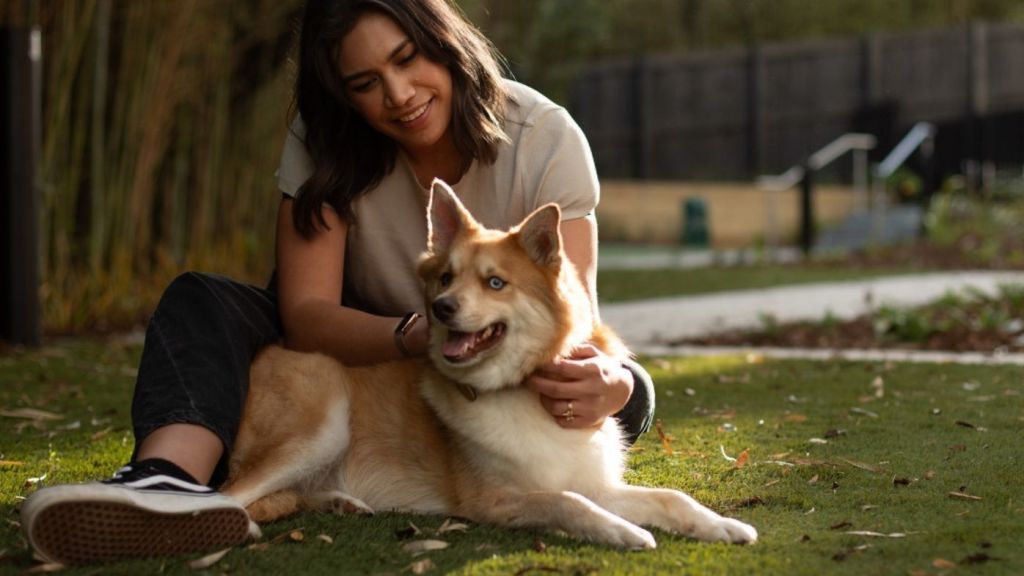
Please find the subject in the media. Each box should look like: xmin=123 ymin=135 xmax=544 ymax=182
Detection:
xmin=22 ymin=0 xmax=653 ymax=563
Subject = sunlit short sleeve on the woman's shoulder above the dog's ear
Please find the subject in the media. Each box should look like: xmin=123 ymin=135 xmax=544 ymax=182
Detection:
xmin=521 ymin=108 xmax=600 ymax=220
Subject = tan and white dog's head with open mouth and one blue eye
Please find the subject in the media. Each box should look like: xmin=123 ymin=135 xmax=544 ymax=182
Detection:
xmin=419 ymin=180 xmax=593 ymax=392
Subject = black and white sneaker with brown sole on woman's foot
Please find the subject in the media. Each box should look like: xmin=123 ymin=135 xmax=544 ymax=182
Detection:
xmin=22 ymin=461 xmax=255 ymax=564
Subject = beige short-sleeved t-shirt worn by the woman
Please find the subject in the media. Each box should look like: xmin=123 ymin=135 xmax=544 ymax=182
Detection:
xmin=278 ymin=81 xmax=599 ymax=316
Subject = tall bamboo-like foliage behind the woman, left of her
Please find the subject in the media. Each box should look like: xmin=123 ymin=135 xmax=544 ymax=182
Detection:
xmin=39 ymin=0 xmax=300 ymax=333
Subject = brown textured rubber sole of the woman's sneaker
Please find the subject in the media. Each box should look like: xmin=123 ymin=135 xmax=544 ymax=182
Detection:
xmin=31 ymin=500 xmax=249 ymax=564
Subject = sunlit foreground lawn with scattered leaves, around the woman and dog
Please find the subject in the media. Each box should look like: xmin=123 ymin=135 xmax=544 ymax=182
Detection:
xmin=0 ymin=341 xmax=1024 ymax=575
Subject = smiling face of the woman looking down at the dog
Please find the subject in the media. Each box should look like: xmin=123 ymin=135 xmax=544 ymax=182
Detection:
xmin=338 ymin=12 xmax=452 ymax=156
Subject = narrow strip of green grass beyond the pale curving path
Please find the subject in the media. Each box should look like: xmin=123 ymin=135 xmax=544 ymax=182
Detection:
xmin=597 ymin=265 xmax=921 ymax=302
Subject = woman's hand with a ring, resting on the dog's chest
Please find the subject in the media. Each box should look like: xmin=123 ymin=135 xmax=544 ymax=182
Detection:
xmin=526 ymin=343 xmax=633 ymax=428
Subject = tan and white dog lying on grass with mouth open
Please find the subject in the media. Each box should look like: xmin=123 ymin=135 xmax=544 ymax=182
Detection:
xmin=224 ymin=180 xmax=757 ymax=549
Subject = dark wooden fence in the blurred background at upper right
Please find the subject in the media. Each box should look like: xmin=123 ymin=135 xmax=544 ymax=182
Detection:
xmin=570 ymin=24 xmax=1024 ymax=179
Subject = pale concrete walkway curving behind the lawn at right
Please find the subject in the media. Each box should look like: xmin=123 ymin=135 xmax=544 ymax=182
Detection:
xmin=601 ymin=271 xmax=1024 ymax=364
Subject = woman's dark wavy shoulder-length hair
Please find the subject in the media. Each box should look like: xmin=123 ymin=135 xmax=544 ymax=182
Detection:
xmin=292 ymin=0 xmax=508 ymax=238
